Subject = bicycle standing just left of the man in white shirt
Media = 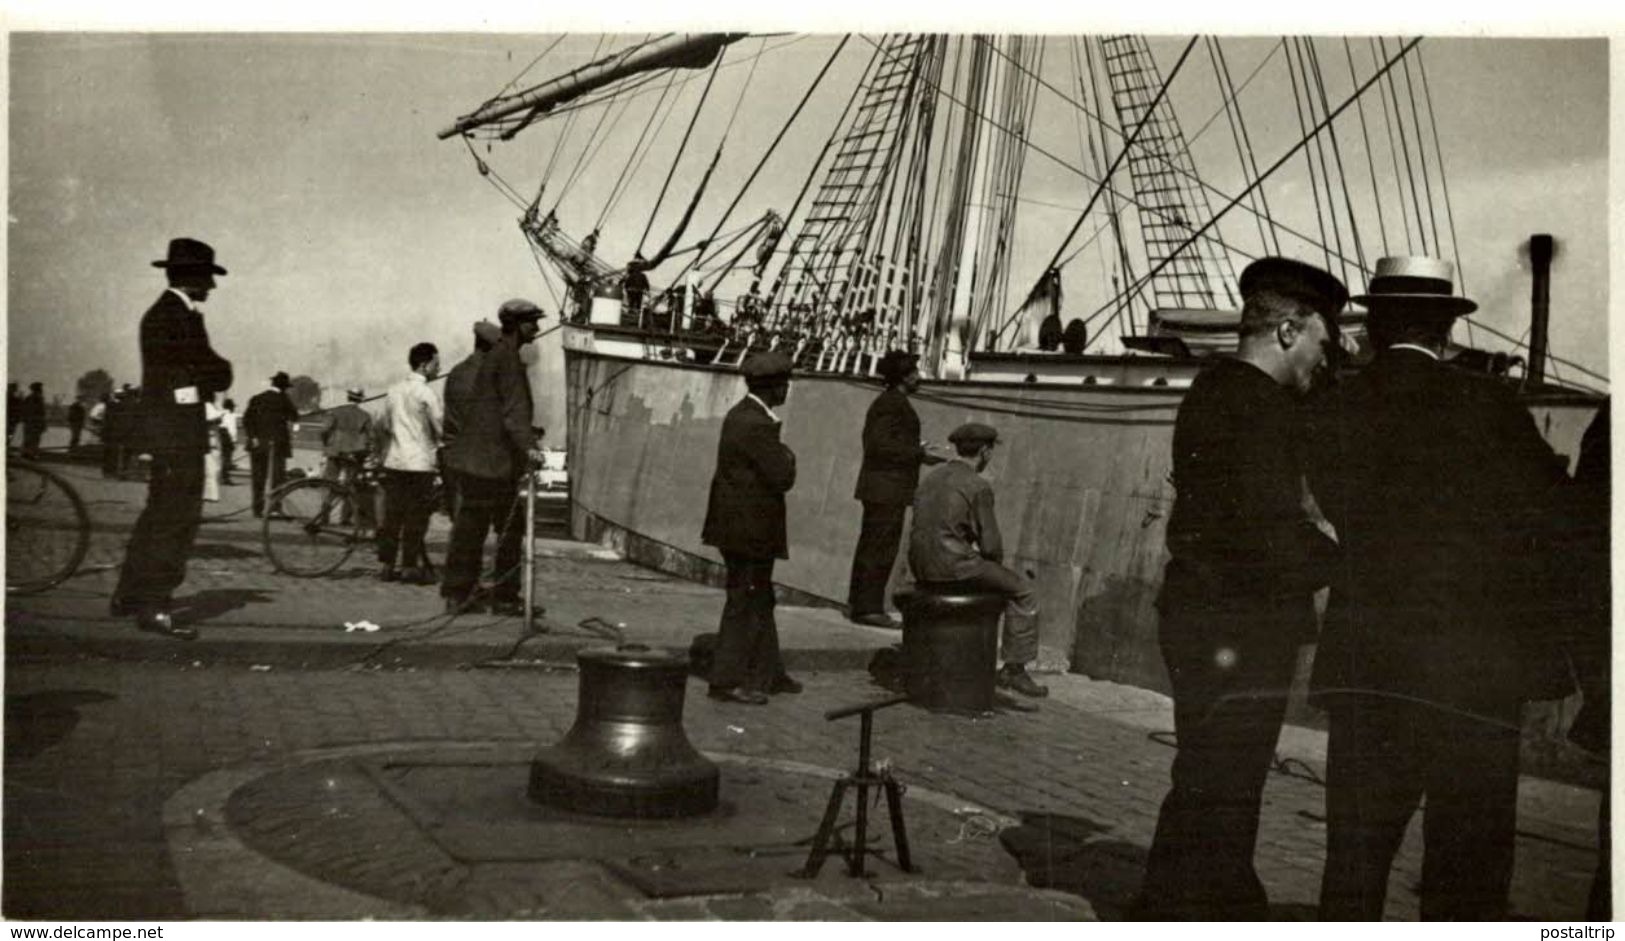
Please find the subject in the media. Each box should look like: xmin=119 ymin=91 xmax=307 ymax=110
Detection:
xmin=262 ymin=466 xmax=445 ymax=579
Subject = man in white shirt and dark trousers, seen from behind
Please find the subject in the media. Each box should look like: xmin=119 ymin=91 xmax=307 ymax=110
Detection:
xmin=379 ymin=343 xmax=444 ymax=585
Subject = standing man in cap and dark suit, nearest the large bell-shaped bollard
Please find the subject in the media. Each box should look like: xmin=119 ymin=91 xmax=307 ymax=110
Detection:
xmin=700 ymin=351 xmax=801 ymax=705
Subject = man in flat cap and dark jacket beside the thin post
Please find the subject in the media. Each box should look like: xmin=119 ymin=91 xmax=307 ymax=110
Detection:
xmin=440 ymin=299 xmax=544 ymax=616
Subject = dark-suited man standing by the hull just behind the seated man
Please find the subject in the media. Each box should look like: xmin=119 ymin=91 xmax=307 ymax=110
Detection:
xmin=847 ymin=349 xmax=943 ymax=627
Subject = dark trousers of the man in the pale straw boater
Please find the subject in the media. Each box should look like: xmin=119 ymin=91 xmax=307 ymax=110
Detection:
xmin=1320 ymin=696 xmax=1518 ymax=921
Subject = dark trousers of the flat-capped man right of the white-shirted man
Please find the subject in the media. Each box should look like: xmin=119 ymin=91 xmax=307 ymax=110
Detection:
xmin=440 ymin=473 xmax=525 ymax=601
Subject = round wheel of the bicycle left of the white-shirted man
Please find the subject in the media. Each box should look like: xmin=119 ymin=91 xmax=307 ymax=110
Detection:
xmin=263 ymin=479 xmax=362 ymax=579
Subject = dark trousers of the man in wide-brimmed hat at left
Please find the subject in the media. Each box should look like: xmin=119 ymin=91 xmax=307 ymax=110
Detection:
xmin=112 ymin=452 xmax=203 ymax=606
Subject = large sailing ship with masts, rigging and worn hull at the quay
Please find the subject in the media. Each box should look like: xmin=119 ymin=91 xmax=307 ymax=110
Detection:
xmin=440 ymin=34 xmax=1601 ymax=687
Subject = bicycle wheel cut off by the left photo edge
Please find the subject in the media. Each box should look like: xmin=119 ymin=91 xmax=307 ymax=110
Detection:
xmin=5 ymin=460 xmax=91 ymax=595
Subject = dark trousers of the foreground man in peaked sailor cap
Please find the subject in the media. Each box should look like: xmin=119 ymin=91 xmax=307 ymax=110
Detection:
xmin=1141 ymin=611 xmax=1297 ymax=921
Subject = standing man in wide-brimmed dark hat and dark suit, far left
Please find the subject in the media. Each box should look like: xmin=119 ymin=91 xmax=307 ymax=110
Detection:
xmin=112 ymin=239 xmax=231 ymax=640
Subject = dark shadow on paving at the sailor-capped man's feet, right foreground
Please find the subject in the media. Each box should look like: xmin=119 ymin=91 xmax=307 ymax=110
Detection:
xmin=999 ymin=811 xmax=1146 ymax=921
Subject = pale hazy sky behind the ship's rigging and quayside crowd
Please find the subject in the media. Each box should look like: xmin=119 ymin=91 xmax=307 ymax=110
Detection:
xmin=7 ymin=23 xmax=1609 ymax=423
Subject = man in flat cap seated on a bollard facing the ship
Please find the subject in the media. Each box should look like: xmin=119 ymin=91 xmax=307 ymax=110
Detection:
xmin=908 ymin=423 xmax=1050 ymax=697
